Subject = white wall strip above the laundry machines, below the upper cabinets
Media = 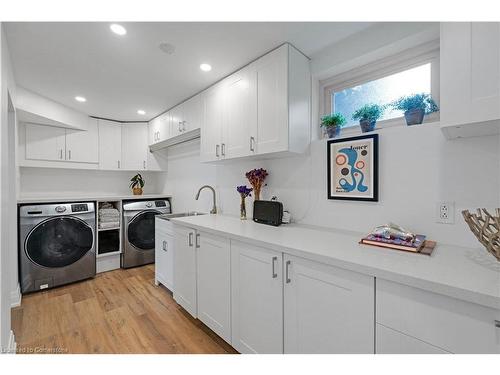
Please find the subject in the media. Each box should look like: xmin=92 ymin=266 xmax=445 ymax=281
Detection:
xmin=19 ymin=167 xmax=163 ymax=198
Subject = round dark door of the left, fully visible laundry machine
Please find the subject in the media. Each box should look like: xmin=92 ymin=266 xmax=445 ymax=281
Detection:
xmin=24 ymin=216 xmax=94 ymax=268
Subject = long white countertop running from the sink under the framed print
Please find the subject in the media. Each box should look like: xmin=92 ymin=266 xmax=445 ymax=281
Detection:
xmin=171 ymin=215 xmax=500 ymax=309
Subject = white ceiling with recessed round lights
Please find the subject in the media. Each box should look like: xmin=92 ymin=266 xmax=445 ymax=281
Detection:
xmin=5 ymin=22 xmax=372 ymax=121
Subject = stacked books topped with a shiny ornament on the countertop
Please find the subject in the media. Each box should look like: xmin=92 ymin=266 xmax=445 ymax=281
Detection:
xmin=360 ymin=223 xmax=436 ymax=255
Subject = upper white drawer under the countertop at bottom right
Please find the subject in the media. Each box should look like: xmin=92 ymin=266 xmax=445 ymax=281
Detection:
xmin=376 ymin=279 xmax=500 ymax=353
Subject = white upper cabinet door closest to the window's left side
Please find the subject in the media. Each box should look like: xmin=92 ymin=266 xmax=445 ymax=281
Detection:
xmin=255 ymin=45 xmax=288 ymax=154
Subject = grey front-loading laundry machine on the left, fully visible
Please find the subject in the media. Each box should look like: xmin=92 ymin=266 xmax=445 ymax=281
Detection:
xmin=19 ymin=202 xmax=96 ymax=293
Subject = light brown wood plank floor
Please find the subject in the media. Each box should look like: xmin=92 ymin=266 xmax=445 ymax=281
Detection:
xmin=12 ymin=265 xmax=236 ymax=354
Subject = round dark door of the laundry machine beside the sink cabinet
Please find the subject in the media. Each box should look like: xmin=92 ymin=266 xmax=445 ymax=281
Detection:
xmin=127 ymin=210 xmax=161 ymax=250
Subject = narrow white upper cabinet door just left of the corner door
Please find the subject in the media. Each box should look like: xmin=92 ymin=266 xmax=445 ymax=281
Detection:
xmin=99 ymin=120 xmax=122 ymax=170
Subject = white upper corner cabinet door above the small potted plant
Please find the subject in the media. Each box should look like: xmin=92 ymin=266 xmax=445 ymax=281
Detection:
xmin=122 ymin=123 xmax=148 ymax=170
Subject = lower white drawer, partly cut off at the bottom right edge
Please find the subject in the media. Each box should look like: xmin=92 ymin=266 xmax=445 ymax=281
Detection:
xmin=375 ymin=324 xmax=449 ymax=354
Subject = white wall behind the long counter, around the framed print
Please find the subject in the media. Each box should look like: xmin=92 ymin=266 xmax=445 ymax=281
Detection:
xmin=158 ymin=24 xmax=500 ymax=247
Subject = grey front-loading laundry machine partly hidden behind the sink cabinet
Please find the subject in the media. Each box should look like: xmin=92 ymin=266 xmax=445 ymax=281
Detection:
xmin=121 ymin=199 xmax=170 ymax=268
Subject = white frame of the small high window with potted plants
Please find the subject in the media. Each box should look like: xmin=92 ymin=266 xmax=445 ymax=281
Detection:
xmin=320 ymin=42 xmax=440 ymax=134
